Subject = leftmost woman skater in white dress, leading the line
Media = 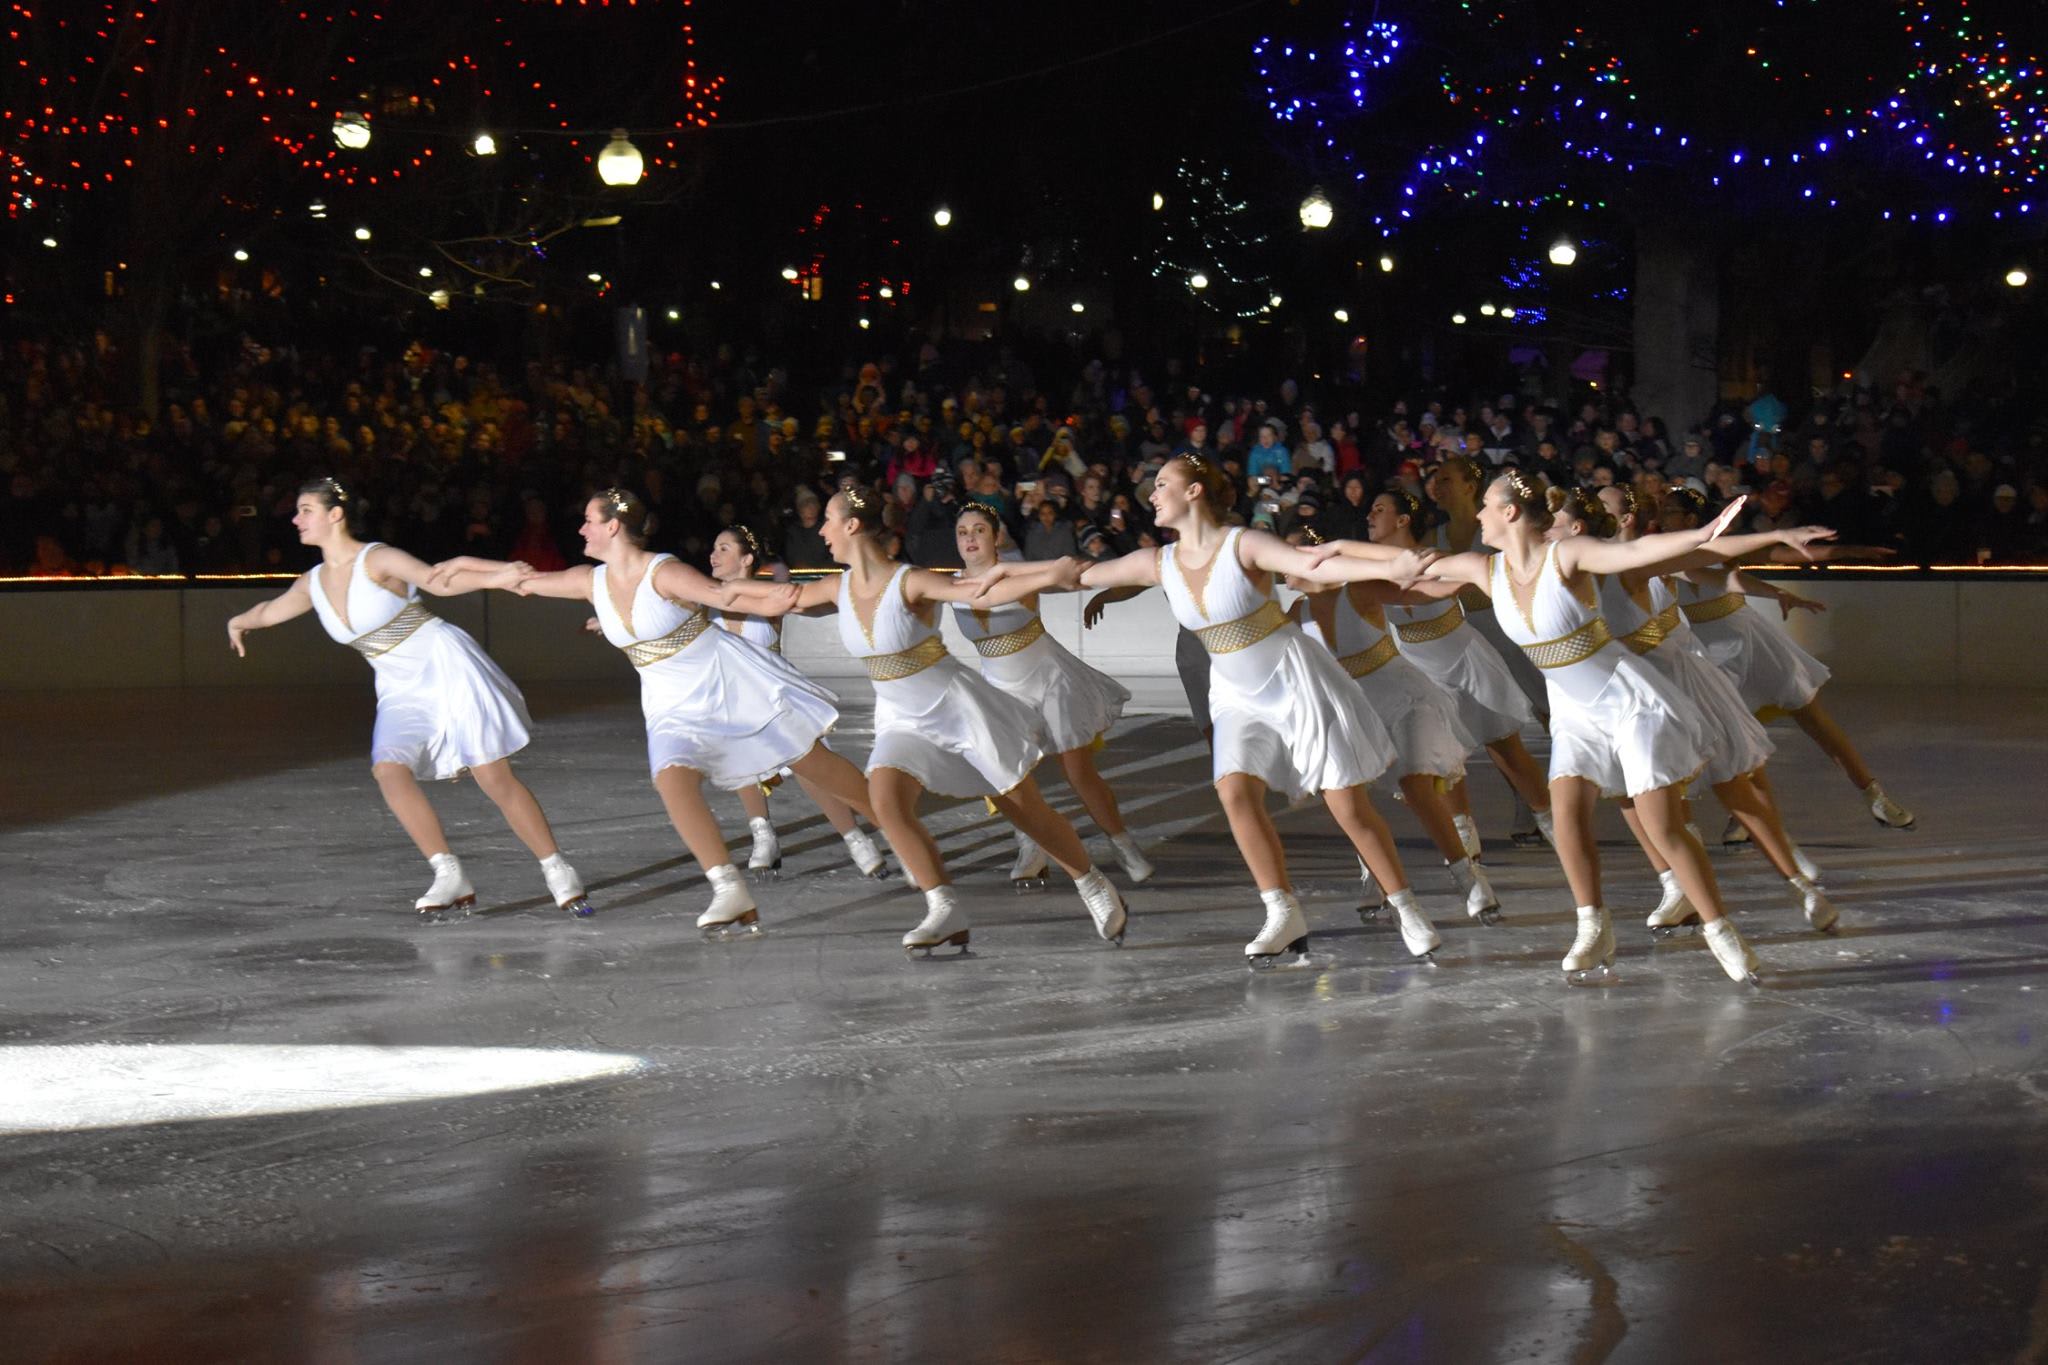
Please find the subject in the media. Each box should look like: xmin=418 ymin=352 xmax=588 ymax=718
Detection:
xmin=227 ymin=479 xmax=590 ymax=919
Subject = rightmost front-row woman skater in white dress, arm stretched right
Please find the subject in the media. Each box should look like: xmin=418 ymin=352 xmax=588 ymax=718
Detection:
xmin=1321 ymin=471 xmax=1759 ymax=980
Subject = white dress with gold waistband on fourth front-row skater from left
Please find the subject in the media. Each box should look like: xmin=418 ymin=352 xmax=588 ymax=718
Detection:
xmin=1159 ymin=528 xmax=1395 ymax=798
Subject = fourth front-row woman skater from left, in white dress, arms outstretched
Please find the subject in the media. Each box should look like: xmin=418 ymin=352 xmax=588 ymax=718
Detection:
xmin=958 ymin=456 xmax=1440 ymax=966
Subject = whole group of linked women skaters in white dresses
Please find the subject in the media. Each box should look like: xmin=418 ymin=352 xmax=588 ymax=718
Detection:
xmin=227 ymin=456 xmax=1913 ymax=980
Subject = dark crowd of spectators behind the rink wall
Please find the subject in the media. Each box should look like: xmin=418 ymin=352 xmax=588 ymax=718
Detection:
xmin=0 ymin=338 xmax=2048 ymax=577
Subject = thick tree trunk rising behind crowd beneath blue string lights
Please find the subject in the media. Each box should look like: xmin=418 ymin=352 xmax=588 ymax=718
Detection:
xmin=1634 ymin=223 xmax=1720 ymax=432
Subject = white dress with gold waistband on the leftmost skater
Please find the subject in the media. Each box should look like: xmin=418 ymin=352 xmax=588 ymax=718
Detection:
xmin=307 ymin=540 xmax=532 ymax=778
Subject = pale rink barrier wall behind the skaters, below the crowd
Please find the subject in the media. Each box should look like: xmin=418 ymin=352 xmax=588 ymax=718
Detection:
xmin=0 ymin=573 xmax=2048 ymax=692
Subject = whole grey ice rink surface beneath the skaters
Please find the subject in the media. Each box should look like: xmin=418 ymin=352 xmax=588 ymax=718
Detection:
xmin=0 ymin=681 xmax=2048 ymax=1363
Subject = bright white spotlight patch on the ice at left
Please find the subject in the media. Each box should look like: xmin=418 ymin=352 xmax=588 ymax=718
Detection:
xmin=0 ymin=1044 xmax=647 ymax=1134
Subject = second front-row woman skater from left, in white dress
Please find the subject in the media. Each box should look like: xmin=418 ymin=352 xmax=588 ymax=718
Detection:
xmin=442 ymin=489 xmax=866 ymax=937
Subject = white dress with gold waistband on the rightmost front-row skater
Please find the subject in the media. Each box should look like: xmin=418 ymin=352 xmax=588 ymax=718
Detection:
xmin=1487 ymin=544 xmax=1714 ymax=796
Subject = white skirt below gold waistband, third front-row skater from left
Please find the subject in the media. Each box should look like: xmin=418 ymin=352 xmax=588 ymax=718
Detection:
xmin=868 ymin=657 xmax=1051 ymax=800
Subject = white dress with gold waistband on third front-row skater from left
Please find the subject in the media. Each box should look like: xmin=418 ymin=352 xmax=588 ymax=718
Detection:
xmin=840 ymin=565 xmax=1051 ymax=798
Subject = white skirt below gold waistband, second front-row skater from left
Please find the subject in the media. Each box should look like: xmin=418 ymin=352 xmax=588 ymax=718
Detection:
xmin=639 ymin=626 xmax=840 ymax=792
